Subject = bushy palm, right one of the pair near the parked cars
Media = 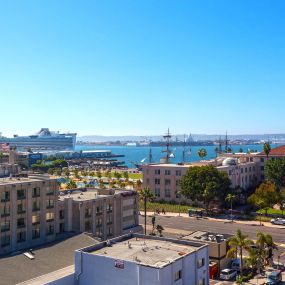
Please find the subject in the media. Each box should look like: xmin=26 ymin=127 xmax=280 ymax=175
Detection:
xmin=256 ymin=232 xmax=277 ymax=265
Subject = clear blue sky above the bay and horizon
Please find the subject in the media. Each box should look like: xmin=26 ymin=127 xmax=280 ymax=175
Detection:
xmin=0 ymin=0 xmax=285 ymax=135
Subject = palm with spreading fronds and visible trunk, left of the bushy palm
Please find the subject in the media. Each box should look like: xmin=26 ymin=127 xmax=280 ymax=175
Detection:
xmin=227 ymin=229 xmax=253 ymax=275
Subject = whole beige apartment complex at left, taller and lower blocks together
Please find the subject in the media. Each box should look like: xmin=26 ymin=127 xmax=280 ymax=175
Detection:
xmin=0 ymin=175 xmax=139 ymax=255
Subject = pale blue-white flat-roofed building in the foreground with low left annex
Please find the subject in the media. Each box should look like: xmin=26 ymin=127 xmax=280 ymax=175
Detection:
xmin=17 ymin=233 xmax=209 ymax=285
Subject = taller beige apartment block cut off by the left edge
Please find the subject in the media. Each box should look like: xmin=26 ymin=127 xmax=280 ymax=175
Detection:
xmin=0 ymin=175 xmax=58 ymax=254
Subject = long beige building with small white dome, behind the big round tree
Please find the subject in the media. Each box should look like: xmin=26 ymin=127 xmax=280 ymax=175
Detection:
xmin=142 ymin=157 xmax=261 ymax=203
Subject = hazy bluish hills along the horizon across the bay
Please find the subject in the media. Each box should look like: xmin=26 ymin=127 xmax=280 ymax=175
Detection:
xmin=77 ymin=134 xmax=285 ymax=142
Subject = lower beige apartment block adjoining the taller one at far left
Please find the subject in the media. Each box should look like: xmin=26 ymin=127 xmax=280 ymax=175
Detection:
xmin=57 ymin=189 xmax=139 ymax=240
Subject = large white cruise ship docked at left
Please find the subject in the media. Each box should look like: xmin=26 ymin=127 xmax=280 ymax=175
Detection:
xmin=0 ymin=128 xmax=77 ymax=150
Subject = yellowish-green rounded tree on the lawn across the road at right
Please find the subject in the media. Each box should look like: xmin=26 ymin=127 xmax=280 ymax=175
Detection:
xmin=248 ymin=181 xmax=278 ymax=216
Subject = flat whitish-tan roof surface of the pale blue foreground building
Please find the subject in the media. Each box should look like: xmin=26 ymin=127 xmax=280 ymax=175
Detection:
xmin=91 ymin=237 xmax=199 ymax=268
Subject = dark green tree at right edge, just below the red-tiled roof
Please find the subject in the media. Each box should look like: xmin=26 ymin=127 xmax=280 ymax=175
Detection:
xmin=265 ymin=157 xmax=285 ymax=189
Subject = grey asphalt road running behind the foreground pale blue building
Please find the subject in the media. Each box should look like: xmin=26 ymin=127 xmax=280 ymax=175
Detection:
xmin=140 ymin=215 xmax=285 ymax=262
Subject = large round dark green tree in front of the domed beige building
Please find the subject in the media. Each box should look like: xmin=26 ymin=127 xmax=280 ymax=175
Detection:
xmin=180 ymin=165 xmax=231 ymax=210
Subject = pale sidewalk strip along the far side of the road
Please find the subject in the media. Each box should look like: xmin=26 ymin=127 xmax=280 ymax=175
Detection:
xmin=141 ymin=212 xmax=285 ymax=229
